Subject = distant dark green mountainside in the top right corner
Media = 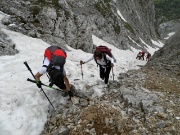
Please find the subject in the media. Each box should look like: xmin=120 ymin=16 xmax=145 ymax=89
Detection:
xmin=153 ymin=0 xmax=180 ymax=40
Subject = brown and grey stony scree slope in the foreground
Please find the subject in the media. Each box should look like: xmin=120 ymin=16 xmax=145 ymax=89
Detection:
xmin=41 ymin=69 xmax=180 ymax=135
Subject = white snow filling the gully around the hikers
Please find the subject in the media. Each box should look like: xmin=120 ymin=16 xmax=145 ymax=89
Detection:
xmin=0 ymin=11 xmax=163 ymax=135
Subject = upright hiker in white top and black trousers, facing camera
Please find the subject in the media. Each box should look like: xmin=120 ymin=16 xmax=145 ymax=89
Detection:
xmin=80 ymin=50 xmax=114 ymax=87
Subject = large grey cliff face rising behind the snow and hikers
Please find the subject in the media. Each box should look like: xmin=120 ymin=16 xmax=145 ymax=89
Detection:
xmin=0 ymin=0 xmax=156 ymax=52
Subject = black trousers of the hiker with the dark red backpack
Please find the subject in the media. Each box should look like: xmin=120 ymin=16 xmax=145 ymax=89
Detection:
xmin=99 ymin=66 xmax=111 ymax=84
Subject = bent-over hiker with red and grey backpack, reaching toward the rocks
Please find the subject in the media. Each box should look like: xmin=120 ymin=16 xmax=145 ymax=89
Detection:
xmin=35 ymin=46 xmax=73 ymax=98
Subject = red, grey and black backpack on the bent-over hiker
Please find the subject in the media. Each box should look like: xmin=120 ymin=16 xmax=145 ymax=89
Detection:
xmin=44 ymin=46 xmax=67 ymax=86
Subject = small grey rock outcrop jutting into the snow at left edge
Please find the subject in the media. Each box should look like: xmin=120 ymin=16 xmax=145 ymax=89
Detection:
xmin=0 ymin=30 xmax=18 ymax=56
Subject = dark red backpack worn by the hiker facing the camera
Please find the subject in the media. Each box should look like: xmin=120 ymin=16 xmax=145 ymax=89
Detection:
xmin=95 ymin=45 xmax=113 ymax=65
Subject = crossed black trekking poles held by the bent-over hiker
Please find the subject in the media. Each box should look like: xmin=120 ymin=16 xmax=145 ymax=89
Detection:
xmin=24 ymin=61 xmax=89 ymax=110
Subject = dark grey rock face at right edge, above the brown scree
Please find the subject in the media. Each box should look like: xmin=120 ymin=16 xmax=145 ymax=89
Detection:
xmin=147 ymin=27 xmax=180 ymax=76
